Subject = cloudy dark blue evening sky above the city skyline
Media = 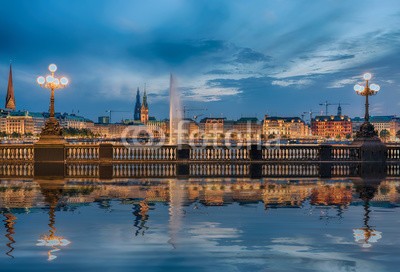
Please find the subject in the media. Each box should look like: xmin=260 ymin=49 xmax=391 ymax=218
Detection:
xmin=0 ymin=0 xmax=400 ymax=119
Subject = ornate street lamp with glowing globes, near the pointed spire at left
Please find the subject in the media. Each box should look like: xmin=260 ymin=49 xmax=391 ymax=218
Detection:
xmin=37 ymin=64 xmax=68 ymax=137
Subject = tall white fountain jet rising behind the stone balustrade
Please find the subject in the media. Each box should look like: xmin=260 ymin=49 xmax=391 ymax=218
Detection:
xmin=169 ymin=74 xmax=183 ymax=145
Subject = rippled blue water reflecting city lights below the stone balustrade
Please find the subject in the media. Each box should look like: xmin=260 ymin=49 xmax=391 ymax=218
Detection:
xmin=0 ymin=178 xmax=400 ymax=272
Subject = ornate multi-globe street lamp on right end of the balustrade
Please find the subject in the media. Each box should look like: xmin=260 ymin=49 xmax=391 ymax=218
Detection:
xmin=354 ymin=73 xmax=380 ymax=138
